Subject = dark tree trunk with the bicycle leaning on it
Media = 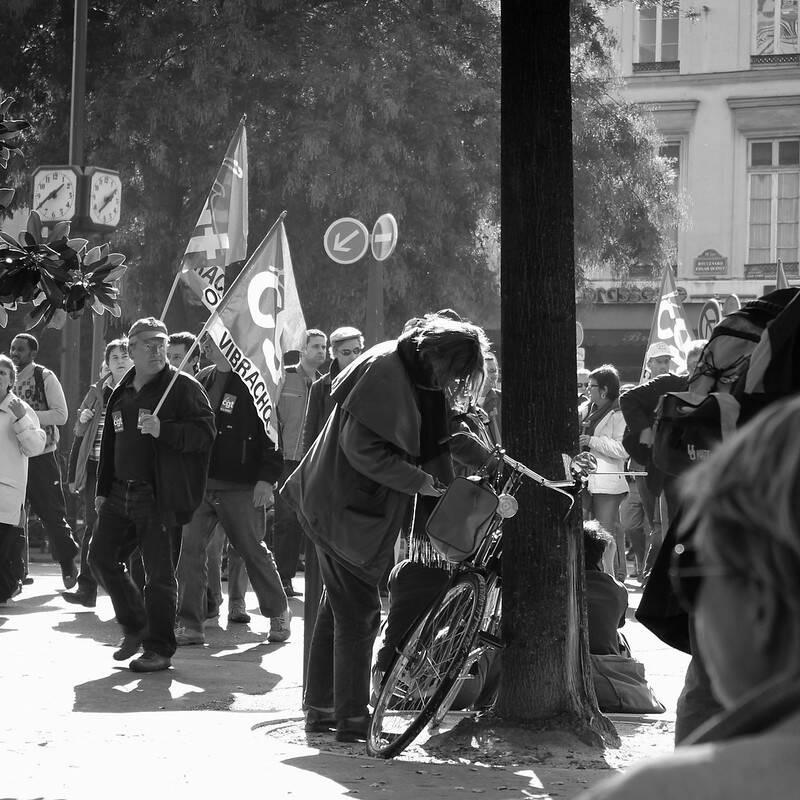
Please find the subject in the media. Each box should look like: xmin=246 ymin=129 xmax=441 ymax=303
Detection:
xmin=496 ymin=0 xmax=618 ymax=744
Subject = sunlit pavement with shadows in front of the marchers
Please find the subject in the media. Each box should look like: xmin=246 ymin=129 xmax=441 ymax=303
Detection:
xmin=0 ymin=563 xmax=686 ymax=800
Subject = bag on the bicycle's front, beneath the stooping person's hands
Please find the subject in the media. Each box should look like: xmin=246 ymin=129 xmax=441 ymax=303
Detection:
xmin=425 ymin=477 xmax=498 ymax=564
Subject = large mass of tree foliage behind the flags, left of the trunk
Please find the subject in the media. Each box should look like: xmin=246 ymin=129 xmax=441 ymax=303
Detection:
xmin=0 ymin=0 xmax=499 ymax=332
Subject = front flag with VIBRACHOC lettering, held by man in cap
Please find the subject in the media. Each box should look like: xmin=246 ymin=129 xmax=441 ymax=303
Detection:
xmin=205 ymin=214 xmax=306 ymax=432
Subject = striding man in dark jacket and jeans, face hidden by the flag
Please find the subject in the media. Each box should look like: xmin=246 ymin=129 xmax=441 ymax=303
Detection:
xmin=177 ymin=336 xmax=290 ymax=645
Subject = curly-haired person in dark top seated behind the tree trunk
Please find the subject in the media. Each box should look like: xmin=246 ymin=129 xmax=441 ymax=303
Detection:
xmin=583 ymin=520 xmax=628 ymax=655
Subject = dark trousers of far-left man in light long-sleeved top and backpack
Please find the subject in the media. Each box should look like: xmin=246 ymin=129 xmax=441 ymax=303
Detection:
xmin=27 ymin=452 xmax=79 ymax=566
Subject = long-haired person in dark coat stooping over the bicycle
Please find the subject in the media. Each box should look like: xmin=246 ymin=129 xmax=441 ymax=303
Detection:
xmin=281 ymin=315 xmax=488 ymax=742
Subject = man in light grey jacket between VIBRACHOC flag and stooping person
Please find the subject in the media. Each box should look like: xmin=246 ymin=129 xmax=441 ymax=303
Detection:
xmin=273 ymin=328 xmax=328 ymax=597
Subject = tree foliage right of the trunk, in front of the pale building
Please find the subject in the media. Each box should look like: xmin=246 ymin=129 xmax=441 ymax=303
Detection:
xmin=571 ymin=0 xmax=681 ymax=280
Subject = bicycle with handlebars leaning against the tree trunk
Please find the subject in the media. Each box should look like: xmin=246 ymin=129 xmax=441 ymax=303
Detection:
xmin=367 ymin=446 xmax=597 ymax=758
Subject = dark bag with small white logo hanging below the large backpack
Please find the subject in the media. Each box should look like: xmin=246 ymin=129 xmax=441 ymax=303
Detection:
xmin=653 ymin=392 xmax=739 ymax=476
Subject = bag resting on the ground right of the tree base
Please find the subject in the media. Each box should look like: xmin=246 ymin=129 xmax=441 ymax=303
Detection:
xmin=591 ymin=651 xmax=666 ymax=714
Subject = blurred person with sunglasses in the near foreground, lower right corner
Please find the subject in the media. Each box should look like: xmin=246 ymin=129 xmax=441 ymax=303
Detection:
xmin=581 ymin=396 xmax=800 ymax=800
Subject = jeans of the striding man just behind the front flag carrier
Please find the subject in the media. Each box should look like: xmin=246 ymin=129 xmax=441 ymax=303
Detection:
xmin=178 ymin=486 xmax=287 ymax=632
